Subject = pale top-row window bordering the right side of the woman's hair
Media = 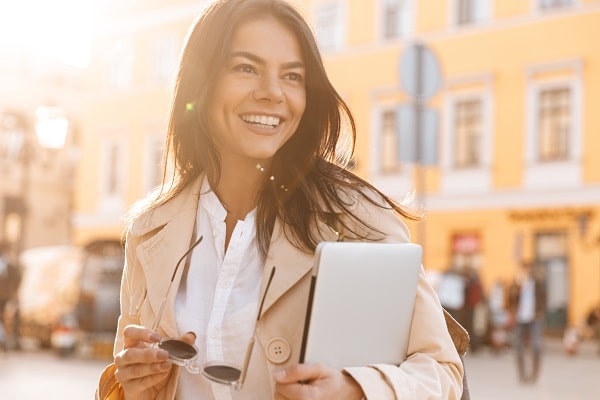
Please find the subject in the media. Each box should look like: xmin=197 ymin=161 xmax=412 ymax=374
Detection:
xmin=315 ymin=1 xmax=344 ymax=51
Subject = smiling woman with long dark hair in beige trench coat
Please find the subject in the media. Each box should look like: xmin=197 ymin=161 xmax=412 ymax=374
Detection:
xmin=100 ymin=0 xmax=464 ymax=400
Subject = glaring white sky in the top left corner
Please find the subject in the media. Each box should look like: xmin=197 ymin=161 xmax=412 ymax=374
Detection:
xmin=0 ymin=0 xmax=94 ymax=67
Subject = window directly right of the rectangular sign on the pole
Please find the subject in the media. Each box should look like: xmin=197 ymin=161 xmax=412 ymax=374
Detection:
xmin=454 ymin=99 xmax=483 ymax=168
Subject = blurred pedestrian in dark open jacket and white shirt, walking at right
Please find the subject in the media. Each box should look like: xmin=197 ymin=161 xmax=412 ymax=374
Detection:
xmin=509 ymin=262 xmax=546 ymax=383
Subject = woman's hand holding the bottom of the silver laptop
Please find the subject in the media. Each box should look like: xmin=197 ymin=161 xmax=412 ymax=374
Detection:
xmin=275 ymin=364 xmax=364 ymax=400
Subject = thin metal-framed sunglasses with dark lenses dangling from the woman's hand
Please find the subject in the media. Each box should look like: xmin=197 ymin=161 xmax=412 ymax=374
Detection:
xmin=152 ymin=236 xmax=275 ymax=390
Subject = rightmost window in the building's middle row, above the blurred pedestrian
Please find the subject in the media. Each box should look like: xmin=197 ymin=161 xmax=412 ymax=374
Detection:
xmin=538 ymin=87 xmax=571 ymax=162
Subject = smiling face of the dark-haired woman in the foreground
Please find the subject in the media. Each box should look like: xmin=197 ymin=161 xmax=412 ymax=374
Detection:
xmin=208 ymin=18 xmax=306 ymax=167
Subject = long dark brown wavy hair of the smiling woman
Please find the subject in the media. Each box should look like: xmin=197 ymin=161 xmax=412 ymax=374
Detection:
xmin=137 ymin=0 xmax=414 ymax=257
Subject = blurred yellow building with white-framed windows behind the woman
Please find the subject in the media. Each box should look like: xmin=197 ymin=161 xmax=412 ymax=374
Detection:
xmin=75 ymin=0 xmax=600 ymax=332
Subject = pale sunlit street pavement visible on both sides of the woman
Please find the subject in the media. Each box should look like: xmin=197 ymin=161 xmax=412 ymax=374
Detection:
xmin=0 ymin=340 xmax=600 ymax=400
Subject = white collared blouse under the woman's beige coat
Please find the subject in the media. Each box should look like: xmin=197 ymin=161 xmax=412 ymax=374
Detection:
xmin=175 ymin=180 xmax=263 ymax=400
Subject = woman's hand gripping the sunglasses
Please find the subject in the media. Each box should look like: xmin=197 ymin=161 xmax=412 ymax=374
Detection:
xmin=115 ymin=325 xmax=173 ymax=400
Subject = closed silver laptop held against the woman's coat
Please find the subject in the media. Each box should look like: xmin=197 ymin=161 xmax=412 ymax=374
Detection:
xmin=300 ymin=242 xmax=422 ymax=368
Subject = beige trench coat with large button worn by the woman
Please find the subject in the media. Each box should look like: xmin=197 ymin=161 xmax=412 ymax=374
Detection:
xmin=114 ymin=179 xmax=468 ymax=400
